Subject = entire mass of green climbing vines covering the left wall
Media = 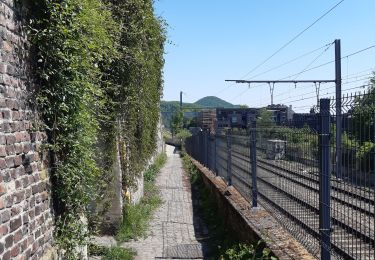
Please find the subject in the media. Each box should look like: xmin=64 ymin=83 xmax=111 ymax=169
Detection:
xmin=19 ymin=0 xmax=165 ymax=259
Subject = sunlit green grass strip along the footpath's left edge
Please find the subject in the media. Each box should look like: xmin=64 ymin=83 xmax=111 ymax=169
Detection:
xmin=116 ymin=153 xmax=167 ymax=242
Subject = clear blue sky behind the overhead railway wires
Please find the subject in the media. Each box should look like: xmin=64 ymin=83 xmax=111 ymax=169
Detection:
xmin=155 ymin=0 xmax=375 ymax=111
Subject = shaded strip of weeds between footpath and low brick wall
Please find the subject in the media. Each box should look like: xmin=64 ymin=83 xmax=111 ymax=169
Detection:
xmin=182 ymin=154 xmax=276 ymax=260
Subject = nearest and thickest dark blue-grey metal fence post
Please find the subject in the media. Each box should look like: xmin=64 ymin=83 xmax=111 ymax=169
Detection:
xmin=319 ymin=99 xmax=331 ymax=260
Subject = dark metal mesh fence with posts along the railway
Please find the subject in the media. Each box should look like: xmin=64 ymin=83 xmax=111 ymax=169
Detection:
xmin=185 ymin=93 xmax=375 ymax=259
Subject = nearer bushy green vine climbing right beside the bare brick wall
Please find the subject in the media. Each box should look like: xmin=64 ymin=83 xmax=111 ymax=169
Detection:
xmin=20 ymin=0 xmax=117 ymax=259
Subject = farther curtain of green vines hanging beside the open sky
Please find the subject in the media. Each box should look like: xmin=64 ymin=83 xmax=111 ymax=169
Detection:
xmin=106 ymin=0 xmax=166 ymax=188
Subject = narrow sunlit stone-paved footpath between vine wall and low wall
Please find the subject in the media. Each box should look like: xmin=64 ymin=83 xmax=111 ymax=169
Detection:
xmin=122 ymin=145 xmax=207 ymax=260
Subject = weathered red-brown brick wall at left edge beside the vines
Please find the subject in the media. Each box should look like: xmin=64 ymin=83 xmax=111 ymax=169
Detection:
xmin=0 ymin=0 xmax=53 ymax=260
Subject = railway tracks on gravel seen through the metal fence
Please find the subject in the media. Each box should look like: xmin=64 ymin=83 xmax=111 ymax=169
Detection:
xmin=213 ymin=141 xmax=375 ymax=259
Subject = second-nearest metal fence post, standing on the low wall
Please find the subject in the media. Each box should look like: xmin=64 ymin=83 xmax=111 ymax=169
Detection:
xmin=250 ymin=119 xmax=258 ymax=208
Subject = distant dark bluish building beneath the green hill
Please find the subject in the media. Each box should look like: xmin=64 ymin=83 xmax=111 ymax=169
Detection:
xmin=216 ymin=108 xmax=258 ymax=128
